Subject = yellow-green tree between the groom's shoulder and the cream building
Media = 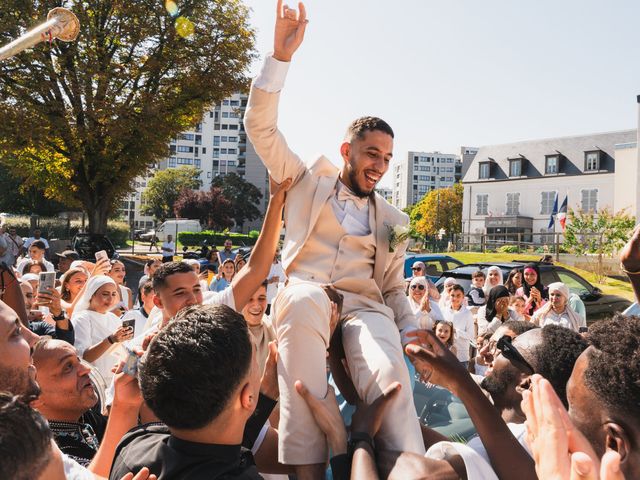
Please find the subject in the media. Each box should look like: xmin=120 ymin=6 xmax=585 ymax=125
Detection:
xmin=409 ymin=183 xmax=464 ymax=236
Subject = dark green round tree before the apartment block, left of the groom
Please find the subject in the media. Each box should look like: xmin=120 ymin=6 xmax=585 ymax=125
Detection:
xmin=211 ymin=173 xmax=262 ymax=228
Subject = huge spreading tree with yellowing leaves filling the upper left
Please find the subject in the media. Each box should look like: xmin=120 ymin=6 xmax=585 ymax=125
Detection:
xmin=0 ymin=0 xmax=254 ymax=233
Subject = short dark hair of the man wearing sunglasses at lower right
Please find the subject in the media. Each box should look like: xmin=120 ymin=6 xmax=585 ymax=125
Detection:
xmin=531 ymin=325 xmax=589 ymax=407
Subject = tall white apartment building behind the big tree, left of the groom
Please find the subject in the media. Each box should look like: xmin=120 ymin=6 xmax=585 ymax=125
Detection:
xmin=121 ymin=93 xmax=269 ymax=232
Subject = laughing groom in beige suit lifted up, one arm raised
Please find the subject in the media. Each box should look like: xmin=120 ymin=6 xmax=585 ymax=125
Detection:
xmin=245 ymin=0 xmax=424 ymax=478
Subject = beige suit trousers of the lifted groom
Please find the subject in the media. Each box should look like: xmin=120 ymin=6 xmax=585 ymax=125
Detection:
xmin=273 ymin=283 xmax=425 ymax=465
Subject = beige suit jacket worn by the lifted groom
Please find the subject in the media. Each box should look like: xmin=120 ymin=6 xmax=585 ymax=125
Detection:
xmin=244 ymin=87 xmax=416 ymax=329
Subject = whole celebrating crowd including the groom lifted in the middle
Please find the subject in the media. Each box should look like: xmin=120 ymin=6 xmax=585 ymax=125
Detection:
xmin=0 ymin=0 xmax=640 ymax=480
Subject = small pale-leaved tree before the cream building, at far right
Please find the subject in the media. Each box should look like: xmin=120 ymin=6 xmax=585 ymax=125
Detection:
xmin=562 ymin=208 xmax=636 ymax=283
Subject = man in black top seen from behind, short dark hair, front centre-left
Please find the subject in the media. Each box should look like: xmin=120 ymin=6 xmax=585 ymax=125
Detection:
xmin=110 ymin=305 xmax=278 ymax=480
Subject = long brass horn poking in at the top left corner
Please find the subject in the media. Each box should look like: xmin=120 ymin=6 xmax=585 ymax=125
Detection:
xmin=0 ymin=7 xmax=80 ymax=60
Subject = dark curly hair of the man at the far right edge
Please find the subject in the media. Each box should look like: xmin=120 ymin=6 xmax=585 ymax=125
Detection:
xmin=584 ymin=314 xmax=640 ymax=421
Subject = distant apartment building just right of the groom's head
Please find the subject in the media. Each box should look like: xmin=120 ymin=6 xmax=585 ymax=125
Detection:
xmin=392 ymin=152 xmax=462 ymax=209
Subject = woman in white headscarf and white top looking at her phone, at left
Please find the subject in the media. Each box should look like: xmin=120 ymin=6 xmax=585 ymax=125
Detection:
xmin=71 ymin=275 xmax=133 ymax=384
